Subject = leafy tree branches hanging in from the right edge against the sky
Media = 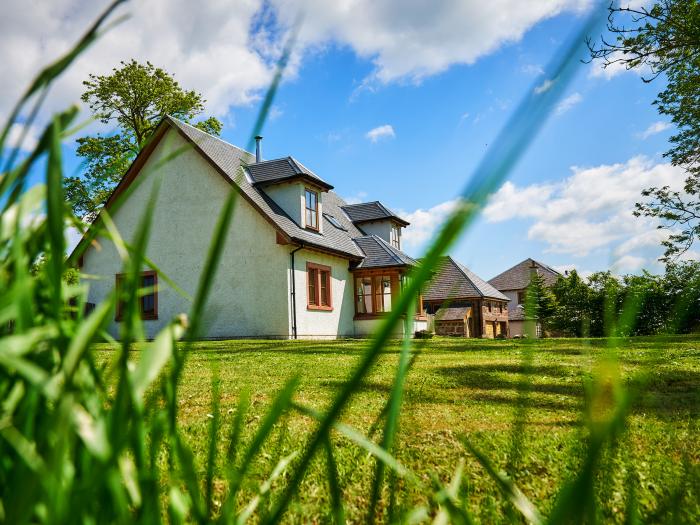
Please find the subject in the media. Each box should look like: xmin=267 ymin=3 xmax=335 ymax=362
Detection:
xmin=589 ymin=0 xmax=700 ymax=262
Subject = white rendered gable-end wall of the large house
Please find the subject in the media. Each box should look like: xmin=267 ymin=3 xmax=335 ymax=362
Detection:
xmin=82 ymin=130 xmax=290 ymax=338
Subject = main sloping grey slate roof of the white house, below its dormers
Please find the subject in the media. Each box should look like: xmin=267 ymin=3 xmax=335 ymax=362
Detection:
xmin=166 ymin=117 xmax=364 ymax=260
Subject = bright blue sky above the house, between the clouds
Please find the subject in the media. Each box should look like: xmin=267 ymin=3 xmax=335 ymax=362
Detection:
xmin=0 ymin=2 xmax=693 ymax=278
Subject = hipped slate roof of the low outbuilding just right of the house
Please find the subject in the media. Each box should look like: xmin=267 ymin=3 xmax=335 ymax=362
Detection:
xmin=423 ymin=256 xmax=508 ymax=301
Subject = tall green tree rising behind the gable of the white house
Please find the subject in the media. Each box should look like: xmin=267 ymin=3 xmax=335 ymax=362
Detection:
xmin=64 ymin=60 xmax=222 ymax=220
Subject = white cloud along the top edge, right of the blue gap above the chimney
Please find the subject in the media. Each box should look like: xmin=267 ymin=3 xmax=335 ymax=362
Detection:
xmin=272 ymin=0 xmax=592 ymax=83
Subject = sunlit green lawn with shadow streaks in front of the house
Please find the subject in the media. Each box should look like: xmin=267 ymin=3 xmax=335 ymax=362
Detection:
xmin=101 ymin=337 xmax=700 ymax=523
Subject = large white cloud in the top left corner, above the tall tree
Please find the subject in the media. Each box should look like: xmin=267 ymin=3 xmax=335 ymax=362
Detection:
xmin=0 ymin=0 xmax=281 ymax=124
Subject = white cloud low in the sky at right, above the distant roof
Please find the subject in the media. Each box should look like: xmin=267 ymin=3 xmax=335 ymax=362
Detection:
xmin=484 ymin=157 xmax=686 ymax=268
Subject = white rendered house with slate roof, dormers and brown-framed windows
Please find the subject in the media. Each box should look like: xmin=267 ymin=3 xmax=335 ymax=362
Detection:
xmin=71 ymin=117 xmax=426 ymax=338
